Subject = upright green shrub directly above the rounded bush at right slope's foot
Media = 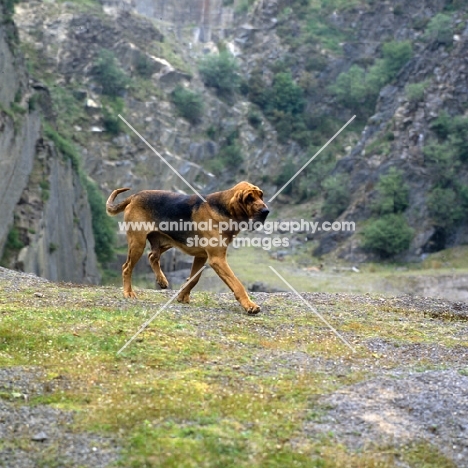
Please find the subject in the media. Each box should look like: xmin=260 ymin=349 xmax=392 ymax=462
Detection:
xmin=372 ymin=167 xmax=409 ymax=215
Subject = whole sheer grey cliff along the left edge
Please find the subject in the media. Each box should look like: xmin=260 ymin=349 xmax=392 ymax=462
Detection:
xmin=0 ymin=7 xmax=100 ymax=283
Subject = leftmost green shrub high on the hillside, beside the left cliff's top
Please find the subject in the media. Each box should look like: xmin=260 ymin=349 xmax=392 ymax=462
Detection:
xmin=92 ymin=49 xmax=130 ymax=96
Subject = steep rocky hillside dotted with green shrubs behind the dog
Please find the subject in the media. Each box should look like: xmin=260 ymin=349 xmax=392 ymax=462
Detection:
xmin=1 ymin=0 xmax=468 ymax=282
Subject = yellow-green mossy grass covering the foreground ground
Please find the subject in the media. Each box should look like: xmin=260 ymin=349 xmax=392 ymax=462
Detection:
xmin=0 ymin=276 xmax=466 ymax=468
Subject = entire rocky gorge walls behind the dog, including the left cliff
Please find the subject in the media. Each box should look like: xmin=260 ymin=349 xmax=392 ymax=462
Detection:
xmin=0 ymin=0 xmax=468 ymax=282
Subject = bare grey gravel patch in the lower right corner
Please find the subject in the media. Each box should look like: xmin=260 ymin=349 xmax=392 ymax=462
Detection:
xmin=304 ymin=370 xmax=468 ymax=468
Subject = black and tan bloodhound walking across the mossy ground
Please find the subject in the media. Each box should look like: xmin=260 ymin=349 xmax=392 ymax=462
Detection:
xmin=106 ymin=182 xmax=269 ymax=314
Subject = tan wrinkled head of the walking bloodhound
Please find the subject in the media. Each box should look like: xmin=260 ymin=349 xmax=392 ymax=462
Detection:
xmin=229 ymin=182 xmax=270 ymax=223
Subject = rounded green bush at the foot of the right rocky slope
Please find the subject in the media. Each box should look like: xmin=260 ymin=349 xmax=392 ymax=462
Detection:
xmin=362 ymin=213 xmax=414 ymax=258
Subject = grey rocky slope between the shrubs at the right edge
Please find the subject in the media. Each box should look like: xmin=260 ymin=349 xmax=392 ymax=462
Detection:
xmin=317 ymin=1 xmax=468 ymax=262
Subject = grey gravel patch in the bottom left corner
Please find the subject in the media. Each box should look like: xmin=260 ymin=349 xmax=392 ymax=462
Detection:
xmin=0 ymin=367 xmax=120 ymax=468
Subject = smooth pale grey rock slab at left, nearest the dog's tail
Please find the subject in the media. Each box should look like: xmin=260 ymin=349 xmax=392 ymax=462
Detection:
xmin=16 ymin=144 xmax=100 ymax=284
